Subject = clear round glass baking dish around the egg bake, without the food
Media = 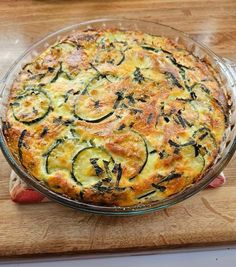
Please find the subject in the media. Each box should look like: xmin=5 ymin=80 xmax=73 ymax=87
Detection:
xmin=0 ymin=19 xmax=236 ymax=215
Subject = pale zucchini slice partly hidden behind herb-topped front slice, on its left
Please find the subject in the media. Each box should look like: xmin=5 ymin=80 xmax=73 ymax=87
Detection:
xmin=46 ymin=138 xmax=86 ymax=173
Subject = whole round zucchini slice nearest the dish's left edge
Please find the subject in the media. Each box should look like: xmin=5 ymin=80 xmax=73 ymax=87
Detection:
xmin=10 ymin=89 xmax=51 ymax=124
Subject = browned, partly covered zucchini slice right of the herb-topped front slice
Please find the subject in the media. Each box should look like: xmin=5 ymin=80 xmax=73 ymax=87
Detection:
xmin=105 ymin=130 xmax=148 ymax=180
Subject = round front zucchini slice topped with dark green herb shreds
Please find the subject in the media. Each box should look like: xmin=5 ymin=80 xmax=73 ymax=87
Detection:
xmin=72 ymin=147 xmax=114 ymax=187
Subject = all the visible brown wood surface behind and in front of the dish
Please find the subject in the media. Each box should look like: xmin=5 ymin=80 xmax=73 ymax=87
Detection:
xmin=0 ymin=0 xmax=236 ymax=257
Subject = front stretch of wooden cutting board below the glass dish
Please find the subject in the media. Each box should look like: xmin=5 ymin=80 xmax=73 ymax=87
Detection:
xmin=0 ymin=155 xmax=236 ymax=257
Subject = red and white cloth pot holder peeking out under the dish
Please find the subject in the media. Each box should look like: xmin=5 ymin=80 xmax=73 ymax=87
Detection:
xmin=9 ymin=171 xmax=225 ymax=204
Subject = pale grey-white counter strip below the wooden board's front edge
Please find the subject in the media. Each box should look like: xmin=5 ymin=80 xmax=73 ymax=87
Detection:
xmin=0 ymin=248 xmax=236 ymax=267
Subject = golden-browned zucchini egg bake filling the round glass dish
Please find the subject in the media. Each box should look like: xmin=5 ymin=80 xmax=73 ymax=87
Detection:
xmin=4 ymin=29 xmax=228 ymax=206
